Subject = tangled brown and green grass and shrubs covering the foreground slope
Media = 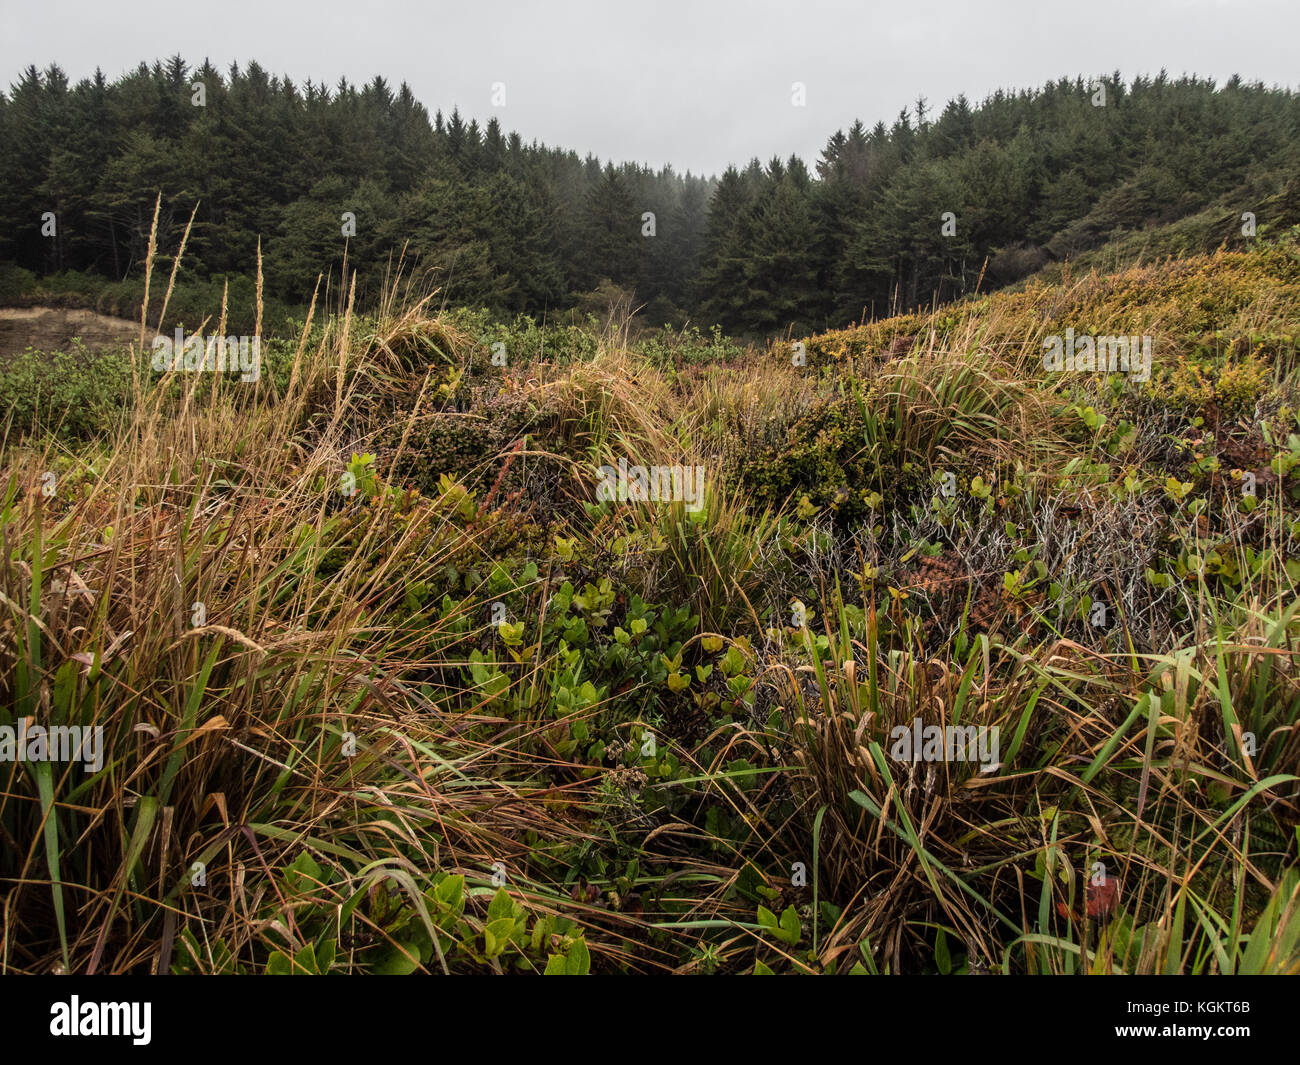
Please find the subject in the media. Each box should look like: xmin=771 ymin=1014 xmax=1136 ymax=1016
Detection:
xmin=0 ymin=204 xmax=1300 ymax=974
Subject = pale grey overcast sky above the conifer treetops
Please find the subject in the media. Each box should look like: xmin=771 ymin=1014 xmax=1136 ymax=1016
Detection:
xmin=0 ymin=0 xmax=1300 ymax=173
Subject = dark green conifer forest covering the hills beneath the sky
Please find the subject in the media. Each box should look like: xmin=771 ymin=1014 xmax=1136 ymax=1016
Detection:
xmin=0 ymin=56 xmax=1300 ymax=334
